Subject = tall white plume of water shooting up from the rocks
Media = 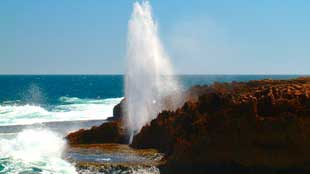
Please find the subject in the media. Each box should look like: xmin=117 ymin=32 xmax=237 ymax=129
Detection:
xmin=125 ymin=1 xmax=179 ymax=141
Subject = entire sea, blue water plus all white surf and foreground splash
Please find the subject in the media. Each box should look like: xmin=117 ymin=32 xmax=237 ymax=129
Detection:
xmin=0 ymin=75 xmax=298 ymax=174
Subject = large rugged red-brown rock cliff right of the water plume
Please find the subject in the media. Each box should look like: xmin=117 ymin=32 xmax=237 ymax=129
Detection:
xmin=132 ymin=78 xmax=310 ymax=173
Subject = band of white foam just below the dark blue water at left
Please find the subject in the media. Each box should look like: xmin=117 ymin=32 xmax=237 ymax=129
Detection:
xmin=0 ymin=97 xmax=122 ymax=126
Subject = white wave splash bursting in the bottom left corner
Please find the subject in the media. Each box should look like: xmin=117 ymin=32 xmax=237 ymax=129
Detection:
xmin=0 ymin=129 xmax=76 ymax=174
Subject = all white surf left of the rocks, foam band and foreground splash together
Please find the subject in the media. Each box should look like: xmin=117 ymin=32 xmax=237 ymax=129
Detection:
xmin=0 ymin=97 xmax=123 ymax=174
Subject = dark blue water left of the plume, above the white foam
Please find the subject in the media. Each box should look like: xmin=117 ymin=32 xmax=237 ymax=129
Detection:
xmin=0 ymin=75 xmax=123 ymax=104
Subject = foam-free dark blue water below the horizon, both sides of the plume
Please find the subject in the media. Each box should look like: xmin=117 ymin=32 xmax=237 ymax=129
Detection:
xmin=0 ymin=75 xmax=298 ymax=105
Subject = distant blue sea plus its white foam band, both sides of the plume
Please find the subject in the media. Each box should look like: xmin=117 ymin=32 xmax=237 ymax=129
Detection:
xmin=0 ymin=75 xmax=298 ymax=126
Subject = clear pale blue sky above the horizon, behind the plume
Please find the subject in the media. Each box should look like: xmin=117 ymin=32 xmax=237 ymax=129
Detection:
xmin=0 ymin=0 xmax=310 ymax=74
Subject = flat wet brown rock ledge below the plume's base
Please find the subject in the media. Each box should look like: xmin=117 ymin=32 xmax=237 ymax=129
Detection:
xmin=64 ymin=144 xmax=164 ymax=174
